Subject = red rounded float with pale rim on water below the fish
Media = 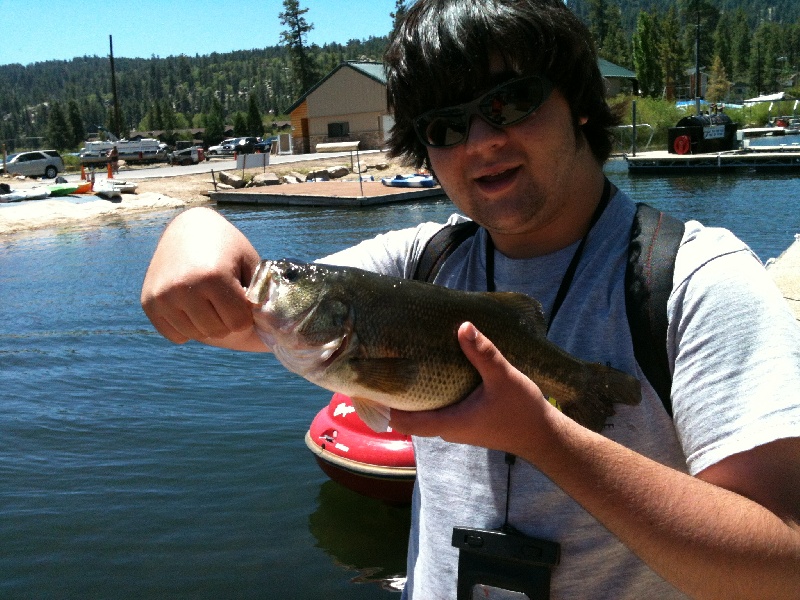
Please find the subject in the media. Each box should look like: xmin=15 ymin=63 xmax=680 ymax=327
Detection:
xmin=306 ymin=394 xmax=417 ymax=504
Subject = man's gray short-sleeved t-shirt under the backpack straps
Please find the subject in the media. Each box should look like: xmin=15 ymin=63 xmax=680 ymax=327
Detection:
xmin=320 ymin=192 xmax=800 ymax=600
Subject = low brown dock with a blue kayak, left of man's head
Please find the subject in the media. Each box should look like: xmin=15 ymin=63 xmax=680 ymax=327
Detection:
xmin=209 ymin=181 xmax=445 ymax=207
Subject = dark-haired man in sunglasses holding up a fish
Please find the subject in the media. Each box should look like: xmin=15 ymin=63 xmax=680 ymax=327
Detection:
xmin=142 ymin=0 xmax=800 ymax=600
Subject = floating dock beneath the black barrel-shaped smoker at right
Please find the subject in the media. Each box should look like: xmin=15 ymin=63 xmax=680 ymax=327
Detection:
xmin=624 ymin=146 xmax=800 ymax=175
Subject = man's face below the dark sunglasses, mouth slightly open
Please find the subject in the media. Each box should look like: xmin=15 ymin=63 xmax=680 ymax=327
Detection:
xmin=428 ymin=69 xmax=599 ymax=256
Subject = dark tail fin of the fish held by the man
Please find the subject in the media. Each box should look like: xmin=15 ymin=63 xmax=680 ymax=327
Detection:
xmin=562 ymin=363 xmax=642 ymax=432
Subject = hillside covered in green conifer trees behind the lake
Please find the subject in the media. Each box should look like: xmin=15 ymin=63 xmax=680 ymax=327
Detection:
xmin=0 ymin=0 xmax=800 ymax=151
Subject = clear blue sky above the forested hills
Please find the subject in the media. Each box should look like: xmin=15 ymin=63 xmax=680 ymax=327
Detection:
xmin=0 ymin=0 xmax=395 ymax=65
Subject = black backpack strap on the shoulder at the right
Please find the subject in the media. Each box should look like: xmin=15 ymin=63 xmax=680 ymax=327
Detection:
xmin=625 ymin=204 xmax=684 ymax=417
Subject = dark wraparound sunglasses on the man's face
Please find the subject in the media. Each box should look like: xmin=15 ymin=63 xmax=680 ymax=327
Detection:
xmin=414 ymin=75 xmax=553 ymax=148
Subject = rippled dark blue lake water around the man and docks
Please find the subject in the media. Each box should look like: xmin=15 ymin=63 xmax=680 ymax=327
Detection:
xmin=0 ymin=161 xmax=800 ymax=600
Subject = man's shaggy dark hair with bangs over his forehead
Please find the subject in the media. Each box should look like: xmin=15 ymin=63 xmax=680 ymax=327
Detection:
xmin=385 ymin=0 xmax=619 ymax=167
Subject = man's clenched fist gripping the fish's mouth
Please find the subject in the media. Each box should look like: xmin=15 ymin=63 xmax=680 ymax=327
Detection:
xmin=141 ymin=208 xmax=266 ymax=350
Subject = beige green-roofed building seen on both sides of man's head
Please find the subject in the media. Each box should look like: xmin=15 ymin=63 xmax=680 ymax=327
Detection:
xmin=286 ymin=59 xmax=636 ymax=153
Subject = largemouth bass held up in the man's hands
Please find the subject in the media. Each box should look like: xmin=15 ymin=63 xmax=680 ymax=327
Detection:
xmin=246 ymin=260 xmax=641 ymax=431
